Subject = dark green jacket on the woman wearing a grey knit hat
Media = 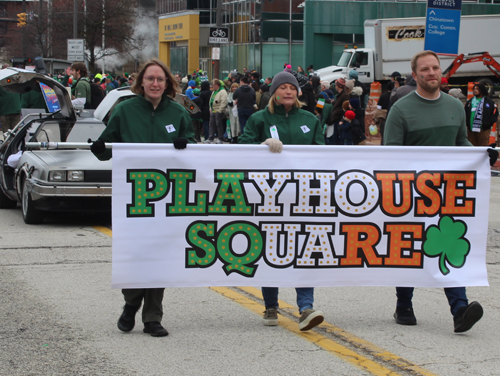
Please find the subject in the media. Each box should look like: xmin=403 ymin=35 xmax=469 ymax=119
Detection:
xmin=238 ymin=105 xmax=325 ymax=145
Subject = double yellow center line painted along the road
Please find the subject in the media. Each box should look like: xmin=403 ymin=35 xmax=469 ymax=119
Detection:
xmin=93 ymin=226 xmax=436 ymax=376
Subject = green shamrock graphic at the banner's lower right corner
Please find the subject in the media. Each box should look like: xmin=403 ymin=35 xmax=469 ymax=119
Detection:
xmin=423 ymin=216 xmax=470 ymax=275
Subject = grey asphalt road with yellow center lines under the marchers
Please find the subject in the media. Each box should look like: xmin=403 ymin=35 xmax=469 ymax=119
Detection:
xmin=0 ymin=176 xmax=500 ymax=376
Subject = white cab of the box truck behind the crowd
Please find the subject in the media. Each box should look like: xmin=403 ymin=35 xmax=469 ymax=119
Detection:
xmin=316 ymin=48 xmax=373 ymax=83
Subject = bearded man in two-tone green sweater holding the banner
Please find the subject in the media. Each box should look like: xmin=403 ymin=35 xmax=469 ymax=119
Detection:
xmin=384 ymin=51 xmax=498 ymax=333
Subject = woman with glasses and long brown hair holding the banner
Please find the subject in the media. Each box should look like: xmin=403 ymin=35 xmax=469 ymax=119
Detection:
xmin=91 ymin=59 xmax=196 ymax=337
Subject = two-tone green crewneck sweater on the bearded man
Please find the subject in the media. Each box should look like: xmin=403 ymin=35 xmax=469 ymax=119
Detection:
xmin=384 ymin=92 xmax=472 ymax=146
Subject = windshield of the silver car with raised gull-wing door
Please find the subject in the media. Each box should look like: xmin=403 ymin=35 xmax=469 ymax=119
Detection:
xmin=31 ymin=121 xmax=105 ymax=142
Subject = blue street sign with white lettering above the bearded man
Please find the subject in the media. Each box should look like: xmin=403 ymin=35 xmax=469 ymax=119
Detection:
xmin=424 ymin=0 xmax=462 ymax=55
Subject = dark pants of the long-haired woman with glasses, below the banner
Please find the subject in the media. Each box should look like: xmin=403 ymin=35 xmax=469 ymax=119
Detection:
xmin=122 ymin=289 xmax=165 ymax=322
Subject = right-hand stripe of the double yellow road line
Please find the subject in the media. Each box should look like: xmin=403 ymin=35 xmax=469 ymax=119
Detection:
xmin=237 ymin=287 xmax=436 ymax=376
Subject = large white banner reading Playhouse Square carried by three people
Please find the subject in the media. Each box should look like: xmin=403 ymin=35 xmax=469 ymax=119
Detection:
xmin=112 ymin=144 xmax=490 ymax=288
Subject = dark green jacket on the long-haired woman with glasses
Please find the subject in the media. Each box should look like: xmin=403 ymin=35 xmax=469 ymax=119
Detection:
xmin=96 ymin=95 xmax=196 ymax=161
